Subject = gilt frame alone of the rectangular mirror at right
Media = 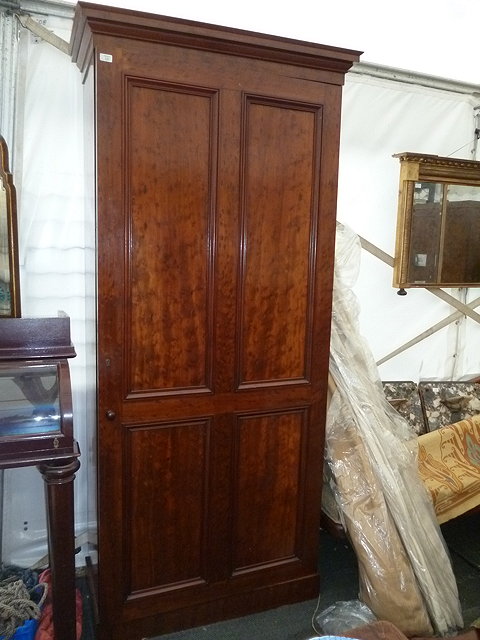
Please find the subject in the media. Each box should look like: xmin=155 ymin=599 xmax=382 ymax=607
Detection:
xmin=393 ymin=152 xmax=480 ymax=290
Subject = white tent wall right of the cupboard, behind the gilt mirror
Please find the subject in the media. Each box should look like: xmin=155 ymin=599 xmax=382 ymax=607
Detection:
xmin=337 ymin=65 xmax=480 ymax=382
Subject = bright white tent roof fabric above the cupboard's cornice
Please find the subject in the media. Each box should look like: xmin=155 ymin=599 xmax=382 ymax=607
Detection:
xmin=91 ymin=0 xmax=478 ymax=82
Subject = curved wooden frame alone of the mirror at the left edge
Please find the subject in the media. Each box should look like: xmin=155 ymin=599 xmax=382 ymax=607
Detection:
xmin=0 ymin=135 xmax=21 ymax=319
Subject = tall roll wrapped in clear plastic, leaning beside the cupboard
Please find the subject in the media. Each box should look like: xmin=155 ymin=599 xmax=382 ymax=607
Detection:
xmin=326 ymin=225 xmax=463 ymax=635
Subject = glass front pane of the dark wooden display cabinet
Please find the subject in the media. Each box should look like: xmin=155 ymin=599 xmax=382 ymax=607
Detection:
xmin=0 ymin=363 xmax=61 ymax=439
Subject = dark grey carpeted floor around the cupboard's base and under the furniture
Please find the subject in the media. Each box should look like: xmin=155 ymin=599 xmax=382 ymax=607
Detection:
xmin=82 ymin=513 xmax=480 ymax=640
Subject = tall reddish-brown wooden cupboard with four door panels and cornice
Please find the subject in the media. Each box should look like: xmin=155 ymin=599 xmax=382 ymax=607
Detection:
xmin=72 ymin=2 xmax=358 ymax=640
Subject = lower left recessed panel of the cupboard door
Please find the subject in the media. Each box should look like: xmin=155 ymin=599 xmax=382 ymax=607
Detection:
xmin=122 ymin=417 xmax=212 ymax=596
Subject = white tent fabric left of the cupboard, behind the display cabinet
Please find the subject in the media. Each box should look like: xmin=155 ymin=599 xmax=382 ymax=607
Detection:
xmin=3 ymin=17 xmax=95 ymax=566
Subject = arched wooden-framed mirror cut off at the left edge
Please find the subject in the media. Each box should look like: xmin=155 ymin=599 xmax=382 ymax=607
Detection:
xmin=0 ymin=136 xmax=21 ymax=318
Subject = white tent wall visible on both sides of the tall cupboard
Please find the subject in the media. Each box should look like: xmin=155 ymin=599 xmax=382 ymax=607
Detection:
xmin=3 ymin=2 xmax=480 ymax=566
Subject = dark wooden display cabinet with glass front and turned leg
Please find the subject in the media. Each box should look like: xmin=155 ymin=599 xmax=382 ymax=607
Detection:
xmin=0 ymin=315 xmax=80 ymax=640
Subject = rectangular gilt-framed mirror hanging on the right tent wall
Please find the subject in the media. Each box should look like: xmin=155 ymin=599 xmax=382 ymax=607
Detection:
xmin=393 ymin=153 xmax=480 ymax=289
